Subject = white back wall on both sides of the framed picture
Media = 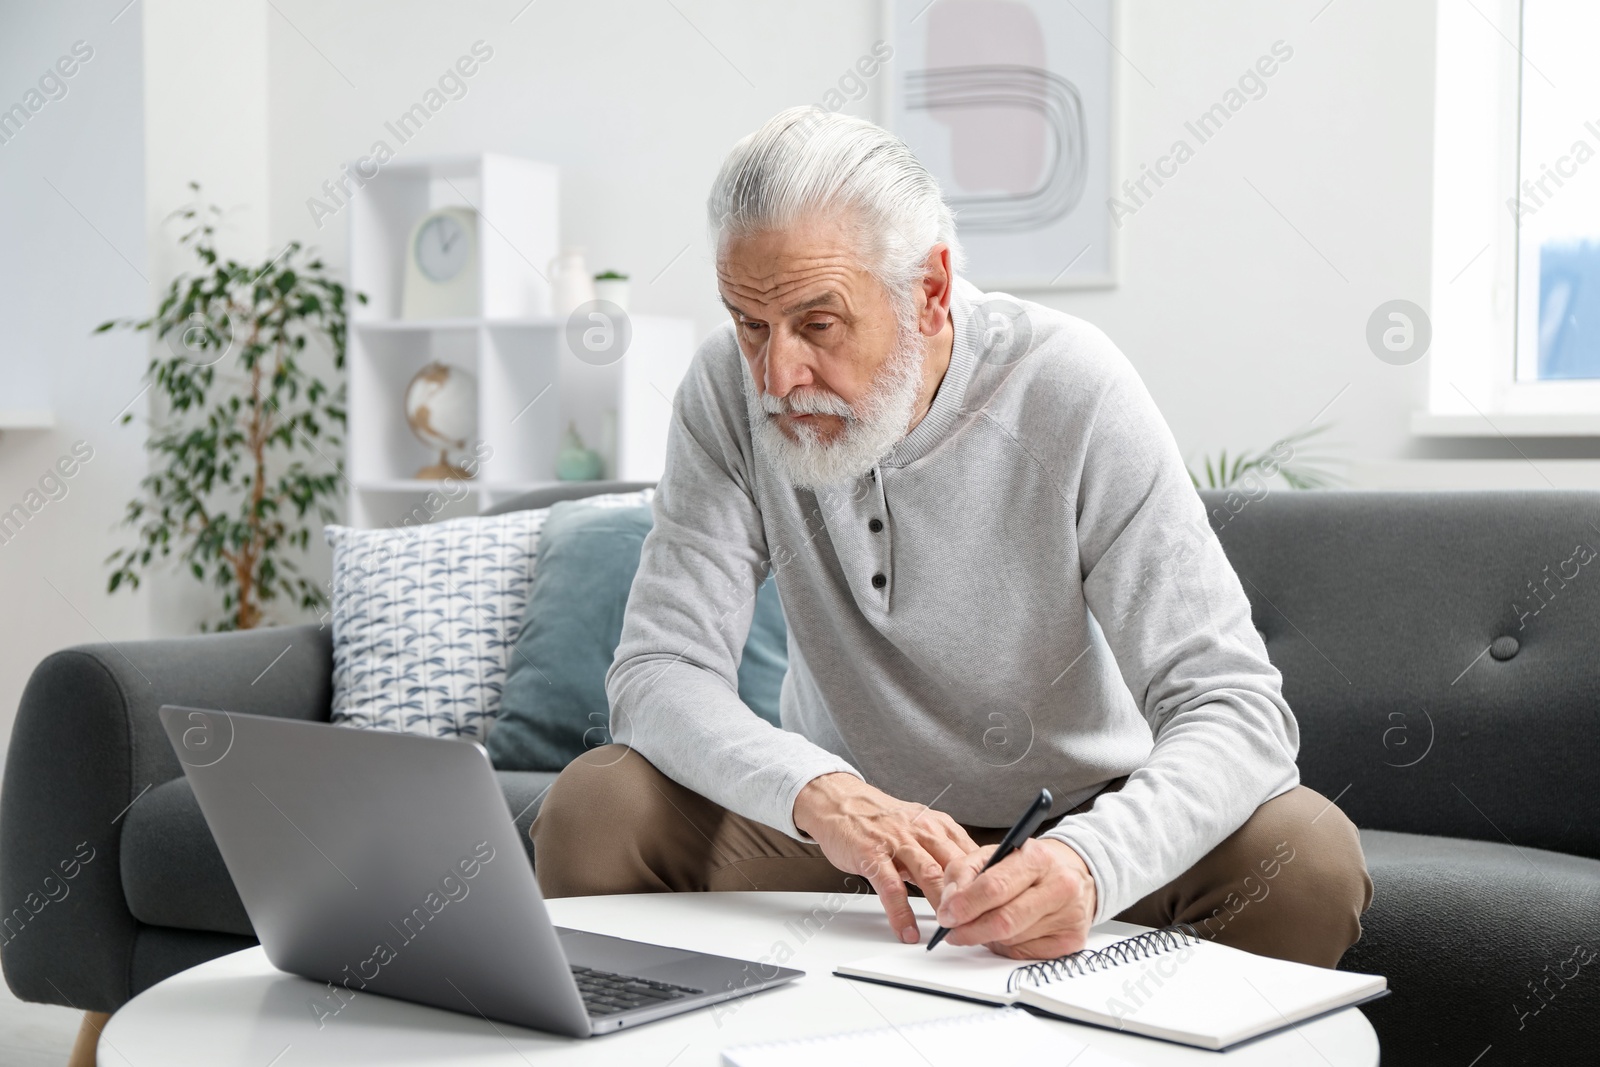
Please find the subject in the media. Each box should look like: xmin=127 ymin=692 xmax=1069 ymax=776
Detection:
xmin=259 ymin=0 xmax=1452 ymax=483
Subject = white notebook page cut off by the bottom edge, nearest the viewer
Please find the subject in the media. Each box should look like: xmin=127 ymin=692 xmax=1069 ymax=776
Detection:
xmin=722 ymin=1008 xmax=1131 ymax=1067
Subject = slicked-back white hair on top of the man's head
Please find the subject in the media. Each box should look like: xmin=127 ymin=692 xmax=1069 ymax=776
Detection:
xmin=706 ymin=106 xmax=965 ymax=322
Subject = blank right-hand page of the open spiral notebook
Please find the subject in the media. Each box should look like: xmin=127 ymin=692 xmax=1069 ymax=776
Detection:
xmin=1018 ymin=941 xmax=1386 ymax=1049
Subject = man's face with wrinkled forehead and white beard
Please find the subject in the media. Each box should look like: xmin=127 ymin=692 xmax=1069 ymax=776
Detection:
xmin=717 ymin=218 xmax=925 ymax=488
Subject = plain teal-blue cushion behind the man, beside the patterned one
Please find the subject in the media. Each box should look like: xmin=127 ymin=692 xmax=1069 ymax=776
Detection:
xmin=485 ymin=501 xmax=789 ymax=771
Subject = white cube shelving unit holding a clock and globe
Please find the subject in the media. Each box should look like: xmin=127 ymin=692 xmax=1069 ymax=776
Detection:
xmin=349 ymin=154 xmax=694 ymax=526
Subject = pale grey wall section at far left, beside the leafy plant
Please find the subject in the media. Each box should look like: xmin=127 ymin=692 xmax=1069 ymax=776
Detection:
xmin=0 ymin=0 xmax=149 ymax=767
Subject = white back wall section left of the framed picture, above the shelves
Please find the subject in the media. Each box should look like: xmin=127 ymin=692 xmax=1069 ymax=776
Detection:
xmin=269 ymin=0 xmax=883 ymax=364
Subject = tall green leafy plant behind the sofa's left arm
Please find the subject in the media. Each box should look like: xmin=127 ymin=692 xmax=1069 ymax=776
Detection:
xmin=96 ymin=182 xmax=366 ymax=630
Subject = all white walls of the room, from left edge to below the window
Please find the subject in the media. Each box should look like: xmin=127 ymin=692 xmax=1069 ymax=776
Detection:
xmin=0 ymin=0 xmax=1574 ymax=751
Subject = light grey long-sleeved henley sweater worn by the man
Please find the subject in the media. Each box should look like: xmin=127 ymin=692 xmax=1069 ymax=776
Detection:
xmin=605 ymin=282 xmax=1299 ymax=921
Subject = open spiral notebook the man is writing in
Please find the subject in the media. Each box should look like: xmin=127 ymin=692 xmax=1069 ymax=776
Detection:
xmin=834 ymin=921 xmax=1387 ymax=1049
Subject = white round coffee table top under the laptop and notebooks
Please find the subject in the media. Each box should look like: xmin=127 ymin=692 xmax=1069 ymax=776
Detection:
xmin=99 ymin=893 xmax=1378 ymax=1067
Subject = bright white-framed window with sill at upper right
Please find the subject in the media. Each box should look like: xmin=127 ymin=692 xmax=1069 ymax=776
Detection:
xmin=1411 ymin=0 xmax=1600 ymax=437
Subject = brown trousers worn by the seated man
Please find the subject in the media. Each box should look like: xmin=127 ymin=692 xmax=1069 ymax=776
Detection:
xmin=531 ymin=745 xmax=1373 ymax=966
